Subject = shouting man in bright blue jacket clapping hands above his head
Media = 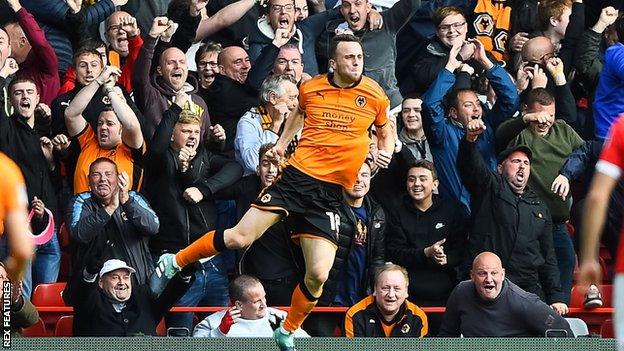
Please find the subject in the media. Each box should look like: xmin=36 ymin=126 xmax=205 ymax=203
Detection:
xmin=422 ymin=37 xmax=520 ymax=213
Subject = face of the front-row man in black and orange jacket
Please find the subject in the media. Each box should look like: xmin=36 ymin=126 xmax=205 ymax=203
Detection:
xmin=374 ymin=271 xmax=407 ymax=315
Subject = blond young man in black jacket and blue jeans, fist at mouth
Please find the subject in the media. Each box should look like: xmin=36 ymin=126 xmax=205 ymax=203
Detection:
xmin=144 ymin=93 xmax=242 ymax=331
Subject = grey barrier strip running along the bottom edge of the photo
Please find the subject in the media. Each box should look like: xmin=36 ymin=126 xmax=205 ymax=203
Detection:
xmin=11 ymin=337 xmax=615 ymax=351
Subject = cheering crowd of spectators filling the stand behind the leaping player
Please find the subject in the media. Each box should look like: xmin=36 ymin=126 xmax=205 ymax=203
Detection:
xmin=0 ymin=0 xmax=624 ymax=337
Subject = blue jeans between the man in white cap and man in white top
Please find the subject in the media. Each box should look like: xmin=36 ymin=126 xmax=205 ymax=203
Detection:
xmin=166 ymin=255 xmax=230 ymax=335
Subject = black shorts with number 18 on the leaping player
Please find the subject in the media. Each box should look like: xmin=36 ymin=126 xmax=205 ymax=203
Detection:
xmin=252 ymin=166 xmax=343 ymax=246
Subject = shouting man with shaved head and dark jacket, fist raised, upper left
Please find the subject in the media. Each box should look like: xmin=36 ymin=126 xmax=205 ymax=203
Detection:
xmin=132 ymin=17 xmax=214 ymax=141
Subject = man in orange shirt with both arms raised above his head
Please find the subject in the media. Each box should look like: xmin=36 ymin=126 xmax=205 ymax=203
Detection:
xmin=65 ymin=66 xmax=145 ymax=194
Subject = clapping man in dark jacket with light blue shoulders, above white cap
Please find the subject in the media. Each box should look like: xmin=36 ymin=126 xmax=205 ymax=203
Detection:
xmin=67 ymin=157 xmax=159 ymax=284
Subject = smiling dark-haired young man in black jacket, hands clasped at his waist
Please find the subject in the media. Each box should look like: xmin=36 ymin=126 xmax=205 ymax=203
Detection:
xmin=386 ymin=160 xmax=468 ymax=335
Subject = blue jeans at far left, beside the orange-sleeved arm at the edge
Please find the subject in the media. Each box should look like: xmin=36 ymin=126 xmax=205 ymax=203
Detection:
xmin=22 ymin=234 xmax=61 ymax=299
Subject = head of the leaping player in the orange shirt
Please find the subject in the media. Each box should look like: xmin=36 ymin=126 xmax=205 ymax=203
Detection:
xmin=330 ymin=41 xmax=364 ymax=83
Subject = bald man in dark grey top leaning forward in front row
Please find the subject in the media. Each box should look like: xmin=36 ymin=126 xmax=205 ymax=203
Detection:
xmin=438 ymin=251 xmax=573 ymax=337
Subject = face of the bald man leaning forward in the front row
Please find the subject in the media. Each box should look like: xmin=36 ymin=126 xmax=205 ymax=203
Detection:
xmin=470 ymin=255 xmax=505 ymax=300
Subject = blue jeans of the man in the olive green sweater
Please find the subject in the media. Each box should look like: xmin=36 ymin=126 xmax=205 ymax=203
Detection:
xmin=553 ymin=223 xmax=576 ymax=305
